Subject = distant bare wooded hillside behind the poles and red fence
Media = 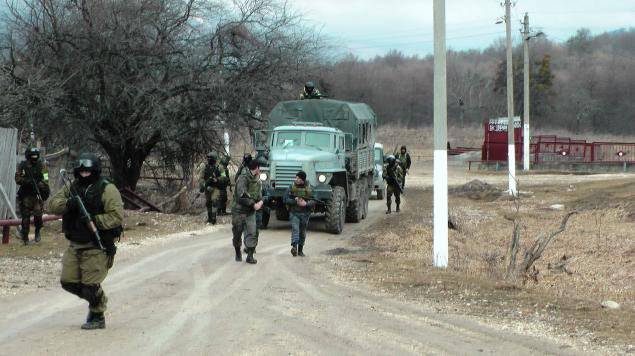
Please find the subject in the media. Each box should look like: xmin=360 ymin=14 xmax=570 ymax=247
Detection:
xmin=320 ymin=29 xmax=635 ymax=134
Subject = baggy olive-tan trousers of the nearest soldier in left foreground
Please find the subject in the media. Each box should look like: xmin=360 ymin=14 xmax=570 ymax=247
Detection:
xmin=60 ymin=247 xmax=112 ymax=313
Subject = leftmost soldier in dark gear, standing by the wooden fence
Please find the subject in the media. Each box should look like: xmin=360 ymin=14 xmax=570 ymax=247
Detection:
xmin=15 ymin=147 xmax=50 ymax=245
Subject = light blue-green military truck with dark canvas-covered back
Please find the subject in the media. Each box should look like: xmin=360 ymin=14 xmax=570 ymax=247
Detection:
xmin=255 ymin=98 xmax=377 ymax=234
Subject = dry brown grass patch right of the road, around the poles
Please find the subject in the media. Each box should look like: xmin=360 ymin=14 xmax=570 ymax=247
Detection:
xmin=332 ymin=179 xmax=635 ymax=345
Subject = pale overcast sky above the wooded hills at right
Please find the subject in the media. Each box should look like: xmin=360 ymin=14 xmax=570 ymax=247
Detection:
xmin=289 ymin=0 xmax=635 ymax=59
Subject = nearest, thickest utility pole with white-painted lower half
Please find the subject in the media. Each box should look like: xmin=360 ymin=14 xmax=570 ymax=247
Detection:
xmin=433 ymin=0 xmax=448 ymax=268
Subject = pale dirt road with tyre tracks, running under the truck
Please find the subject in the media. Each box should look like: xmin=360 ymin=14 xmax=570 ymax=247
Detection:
xmin=0 ymin=195 xmax=592 ymax=355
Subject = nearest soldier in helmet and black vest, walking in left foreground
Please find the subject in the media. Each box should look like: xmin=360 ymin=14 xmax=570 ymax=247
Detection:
xmin=49 ymin=153 xmax=123 ymax=330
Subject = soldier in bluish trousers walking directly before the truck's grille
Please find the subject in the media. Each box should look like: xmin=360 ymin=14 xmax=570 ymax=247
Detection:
xmin=284 ymin=171 xmax=315 ymax=257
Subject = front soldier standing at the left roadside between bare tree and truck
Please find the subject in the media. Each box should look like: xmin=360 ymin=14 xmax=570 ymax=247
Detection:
xmin=198 ymin=151 xmax=229 ymax=225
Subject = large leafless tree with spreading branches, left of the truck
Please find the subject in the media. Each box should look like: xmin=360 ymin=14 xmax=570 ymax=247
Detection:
xmin=2 ymin=0 xmax=321 ymax=189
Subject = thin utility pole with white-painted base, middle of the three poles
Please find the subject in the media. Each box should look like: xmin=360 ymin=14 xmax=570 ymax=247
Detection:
xmin=505 ymin=0 xmax=518 ymax=196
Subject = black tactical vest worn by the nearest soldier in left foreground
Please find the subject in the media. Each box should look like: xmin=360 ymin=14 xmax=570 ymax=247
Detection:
xmin=62 ymin=178 xmax=122 ymax=244
